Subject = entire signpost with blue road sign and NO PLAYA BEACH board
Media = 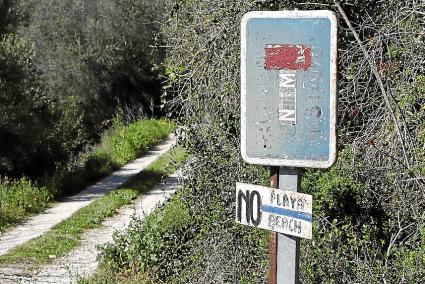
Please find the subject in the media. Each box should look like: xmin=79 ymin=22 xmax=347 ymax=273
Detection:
xmin=236 ymin=8 xmax=337 ymax=284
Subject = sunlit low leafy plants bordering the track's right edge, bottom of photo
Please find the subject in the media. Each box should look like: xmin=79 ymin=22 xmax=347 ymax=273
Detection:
xmin=79 ymin=191 xmax=193 ymax=284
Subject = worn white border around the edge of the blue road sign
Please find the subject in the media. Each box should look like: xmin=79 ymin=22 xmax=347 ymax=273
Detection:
xmin=240 ymin=10 xmax=337 ymax=168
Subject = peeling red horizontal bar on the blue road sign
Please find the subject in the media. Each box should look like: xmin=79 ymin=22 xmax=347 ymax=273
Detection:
xmin=264 ymin=44 xmax=311 ymax=70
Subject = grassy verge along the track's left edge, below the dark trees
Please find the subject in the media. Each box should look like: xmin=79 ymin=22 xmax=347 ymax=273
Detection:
xmin=0 ymin=118 xmax=175 ymax=232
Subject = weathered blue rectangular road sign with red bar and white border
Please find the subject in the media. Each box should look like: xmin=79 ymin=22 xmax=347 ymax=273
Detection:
xmin=241 ymin=11 xmax=337 ymax=168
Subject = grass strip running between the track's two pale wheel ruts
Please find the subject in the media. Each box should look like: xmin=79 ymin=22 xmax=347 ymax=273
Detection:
xmin=0 ymin=147 xmax=186 ymax=269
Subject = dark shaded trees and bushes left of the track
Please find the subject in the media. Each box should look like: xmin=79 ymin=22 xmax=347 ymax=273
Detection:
xmin=0 ymin=0 xmax=164 ymax=179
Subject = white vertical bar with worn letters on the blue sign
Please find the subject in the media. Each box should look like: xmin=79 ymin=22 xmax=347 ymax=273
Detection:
xmin=278 ymin=70 xmax=297 ymax=124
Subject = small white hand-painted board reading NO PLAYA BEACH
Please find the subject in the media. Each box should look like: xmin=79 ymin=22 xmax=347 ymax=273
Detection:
xmin=236 ymin=183 xmax=313 ymax=239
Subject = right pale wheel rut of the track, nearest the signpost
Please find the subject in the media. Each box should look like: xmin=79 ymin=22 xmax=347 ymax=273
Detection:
xmin=0 ymin=173 xmax=182 ymax=284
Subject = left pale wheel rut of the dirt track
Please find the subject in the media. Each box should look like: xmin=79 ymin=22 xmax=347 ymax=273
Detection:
xmin=0 ymin=135 xmax=175 ymax=256
